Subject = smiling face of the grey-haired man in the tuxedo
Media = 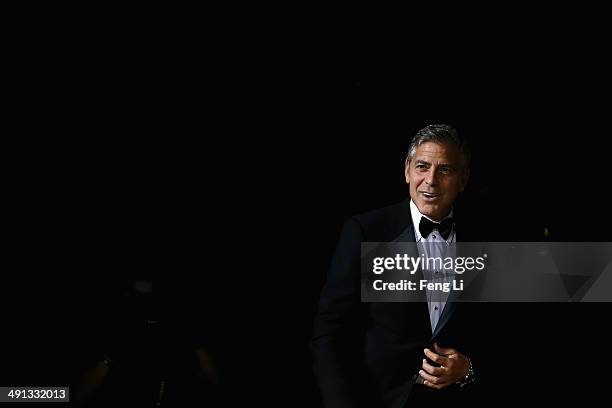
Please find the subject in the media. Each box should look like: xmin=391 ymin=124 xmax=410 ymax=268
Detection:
xmin=405 ymin=142 xmax=469 ymax=221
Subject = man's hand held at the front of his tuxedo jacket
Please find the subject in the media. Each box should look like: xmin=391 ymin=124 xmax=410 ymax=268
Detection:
xmin=419 ymin=343 xmax=470 ymax=389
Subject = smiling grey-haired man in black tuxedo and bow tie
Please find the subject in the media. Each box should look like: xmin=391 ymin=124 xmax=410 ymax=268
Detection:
xmin=311 ymin=125 xmax=478 ymax=408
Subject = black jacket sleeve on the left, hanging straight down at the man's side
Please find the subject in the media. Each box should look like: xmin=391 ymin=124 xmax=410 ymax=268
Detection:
xmin=311 ymin=219 xmax=364 ymax=407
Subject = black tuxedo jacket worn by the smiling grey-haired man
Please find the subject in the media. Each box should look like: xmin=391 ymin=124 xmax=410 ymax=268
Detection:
xmin=311 ymin=199 xmax=480 ymax=408
